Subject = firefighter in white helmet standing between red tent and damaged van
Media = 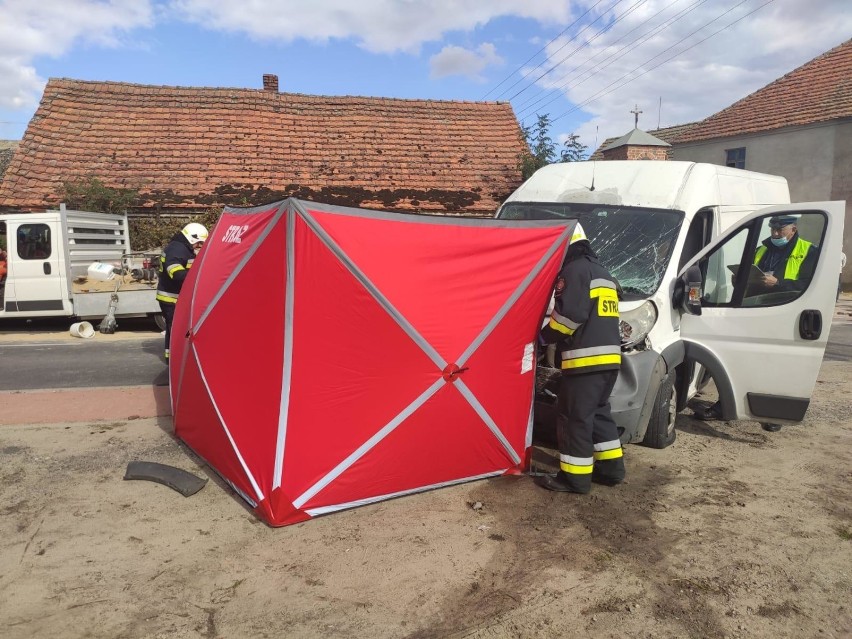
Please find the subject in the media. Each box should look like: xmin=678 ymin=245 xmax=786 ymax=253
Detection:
xmin=535 ymin=223 xmax=625 ymax=493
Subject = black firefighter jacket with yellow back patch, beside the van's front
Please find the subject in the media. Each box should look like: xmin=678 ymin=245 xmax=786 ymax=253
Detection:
xmin=541 ymin=247 xmax=621 ymax=375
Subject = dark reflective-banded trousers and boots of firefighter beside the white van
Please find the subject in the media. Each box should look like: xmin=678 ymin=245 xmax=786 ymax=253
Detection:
xmin=556 ymin=371 xmax=624 ymax=492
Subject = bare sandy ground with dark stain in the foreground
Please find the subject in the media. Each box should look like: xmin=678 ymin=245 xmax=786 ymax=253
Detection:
xmin=0 ymin=362 xmax=852 ymax=639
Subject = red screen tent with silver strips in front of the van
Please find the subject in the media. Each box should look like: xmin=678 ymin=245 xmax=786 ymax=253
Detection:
xmin=169 ymin=199 xmax=573 ymax=526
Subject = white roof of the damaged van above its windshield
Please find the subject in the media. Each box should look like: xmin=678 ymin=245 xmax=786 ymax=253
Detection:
xmin=506 ymin=160 xmax=790 ymax=212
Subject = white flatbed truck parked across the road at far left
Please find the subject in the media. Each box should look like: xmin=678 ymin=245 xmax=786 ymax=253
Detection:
xmin=0 ymin=205 xmax=162 ymax=332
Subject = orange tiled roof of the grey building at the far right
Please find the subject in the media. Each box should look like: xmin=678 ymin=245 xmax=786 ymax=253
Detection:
xmin=677 ymin=40 xmax=852 ymax=143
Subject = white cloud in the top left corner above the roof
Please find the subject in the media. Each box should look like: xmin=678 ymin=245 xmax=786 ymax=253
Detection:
xmin=0 ymin=0 xmax=152 ymax=109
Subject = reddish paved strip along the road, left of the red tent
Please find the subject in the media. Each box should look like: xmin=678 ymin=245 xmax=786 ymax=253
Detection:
xmin=0 ymin=386 xmax=172 ymax=426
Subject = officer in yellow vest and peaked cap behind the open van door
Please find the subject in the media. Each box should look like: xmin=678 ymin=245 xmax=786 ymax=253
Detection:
xmin=695 ymin=215 xmax=819 ymax=432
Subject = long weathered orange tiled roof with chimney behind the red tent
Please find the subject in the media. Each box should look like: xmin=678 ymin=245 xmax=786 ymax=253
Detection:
xmin=0 ymin=78 xmax=524 ymax=213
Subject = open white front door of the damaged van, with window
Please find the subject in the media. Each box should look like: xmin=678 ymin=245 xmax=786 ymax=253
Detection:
xmin=675 ymin=202 xmax=845 ymax=423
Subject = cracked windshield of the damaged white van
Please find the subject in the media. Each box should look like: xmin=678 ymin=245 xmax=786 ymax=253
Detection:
xmin=497 ymin=202 xmax=684 ymax=299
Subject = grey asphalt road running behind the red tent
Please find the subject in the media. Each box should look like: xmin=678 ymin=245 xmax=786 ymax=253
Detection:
xmin=0 ymin=312 xmax=852 ymax=391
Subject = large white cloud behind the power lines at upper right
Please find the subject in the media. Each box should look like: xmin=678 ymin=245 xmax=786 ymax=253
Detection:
xmin=507 ymin=0 xmax=852 ymax=150
